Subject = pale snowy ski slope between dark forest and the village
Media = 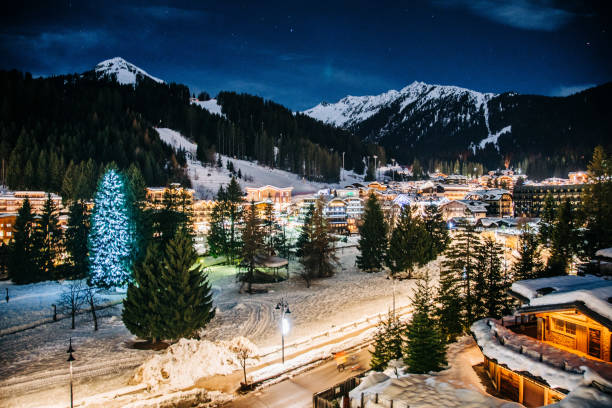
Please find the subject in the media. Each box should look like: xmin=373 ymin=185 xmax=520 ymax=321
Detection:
xmin=156 ymin=128 xmax=363 ymax=199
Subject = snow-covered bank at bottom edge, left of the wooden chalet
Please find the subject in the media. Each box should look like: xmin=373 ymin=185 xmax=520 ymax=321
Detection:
xmin=349 ymin=361 xmax=522 ymax=408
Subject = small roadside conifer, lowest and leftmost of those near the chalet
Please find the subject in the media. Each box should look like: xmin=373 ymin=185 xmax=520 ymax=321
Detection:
xmin=370 ymin=312 xmax=405 ymax=371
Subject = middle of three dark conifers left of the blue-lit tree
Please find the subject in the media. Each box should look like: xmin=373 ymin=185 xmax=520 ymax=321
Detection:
xmin=35 ymin=193 xmax=63 ymax=280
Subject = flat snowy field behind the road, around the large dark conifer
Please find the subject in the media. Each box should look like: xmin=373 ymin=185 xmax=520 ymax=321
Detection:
xmin=0 ymin=244 xmax=439 ymax=407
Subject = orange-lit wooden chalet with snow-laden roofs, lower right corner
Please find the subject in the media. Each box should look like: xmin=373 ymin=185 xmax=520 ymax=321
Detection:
xmin=471 ymin=275 xmax=612 ymax=407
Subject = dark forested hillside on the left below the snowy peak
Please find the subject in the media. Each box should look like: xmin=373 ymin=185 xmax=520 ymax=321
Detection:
xmin=0 ymin=63 xmax=367 ymax=196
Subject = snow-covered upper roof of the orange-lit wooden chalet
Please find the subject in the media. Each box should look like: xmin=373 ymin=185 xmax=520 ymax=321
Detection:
xmin=510 ymin=275 xmax=612 ymax=323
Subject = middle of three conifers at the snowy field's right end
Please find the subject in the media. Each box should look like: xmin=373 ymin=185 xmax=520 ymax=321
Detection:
xmin=386 ymin=206 xmax=429 ymax=279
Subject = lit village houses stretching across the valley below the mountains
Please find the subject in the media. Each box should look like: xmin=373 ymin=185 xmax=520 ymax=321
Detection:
xmin=0 ymin=170 xmax=587 ymax=247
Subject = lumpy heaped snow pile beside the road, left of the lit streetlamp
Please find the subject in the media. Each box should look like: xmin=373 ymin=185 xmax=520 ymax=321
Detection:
xmin=130 ymin=337 xmax=258 ymax=389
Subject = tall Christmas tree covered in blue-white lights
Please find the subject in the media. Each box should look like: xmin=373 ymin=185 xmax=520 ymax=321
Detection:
xmin=88 ymin=169 xmax=136 ymax=287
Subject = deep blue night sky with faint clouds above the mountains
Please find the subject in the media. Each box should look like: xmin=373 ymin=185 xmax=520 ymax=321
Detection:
xmin=0 ymin=0 xmax=612 ymax=110
